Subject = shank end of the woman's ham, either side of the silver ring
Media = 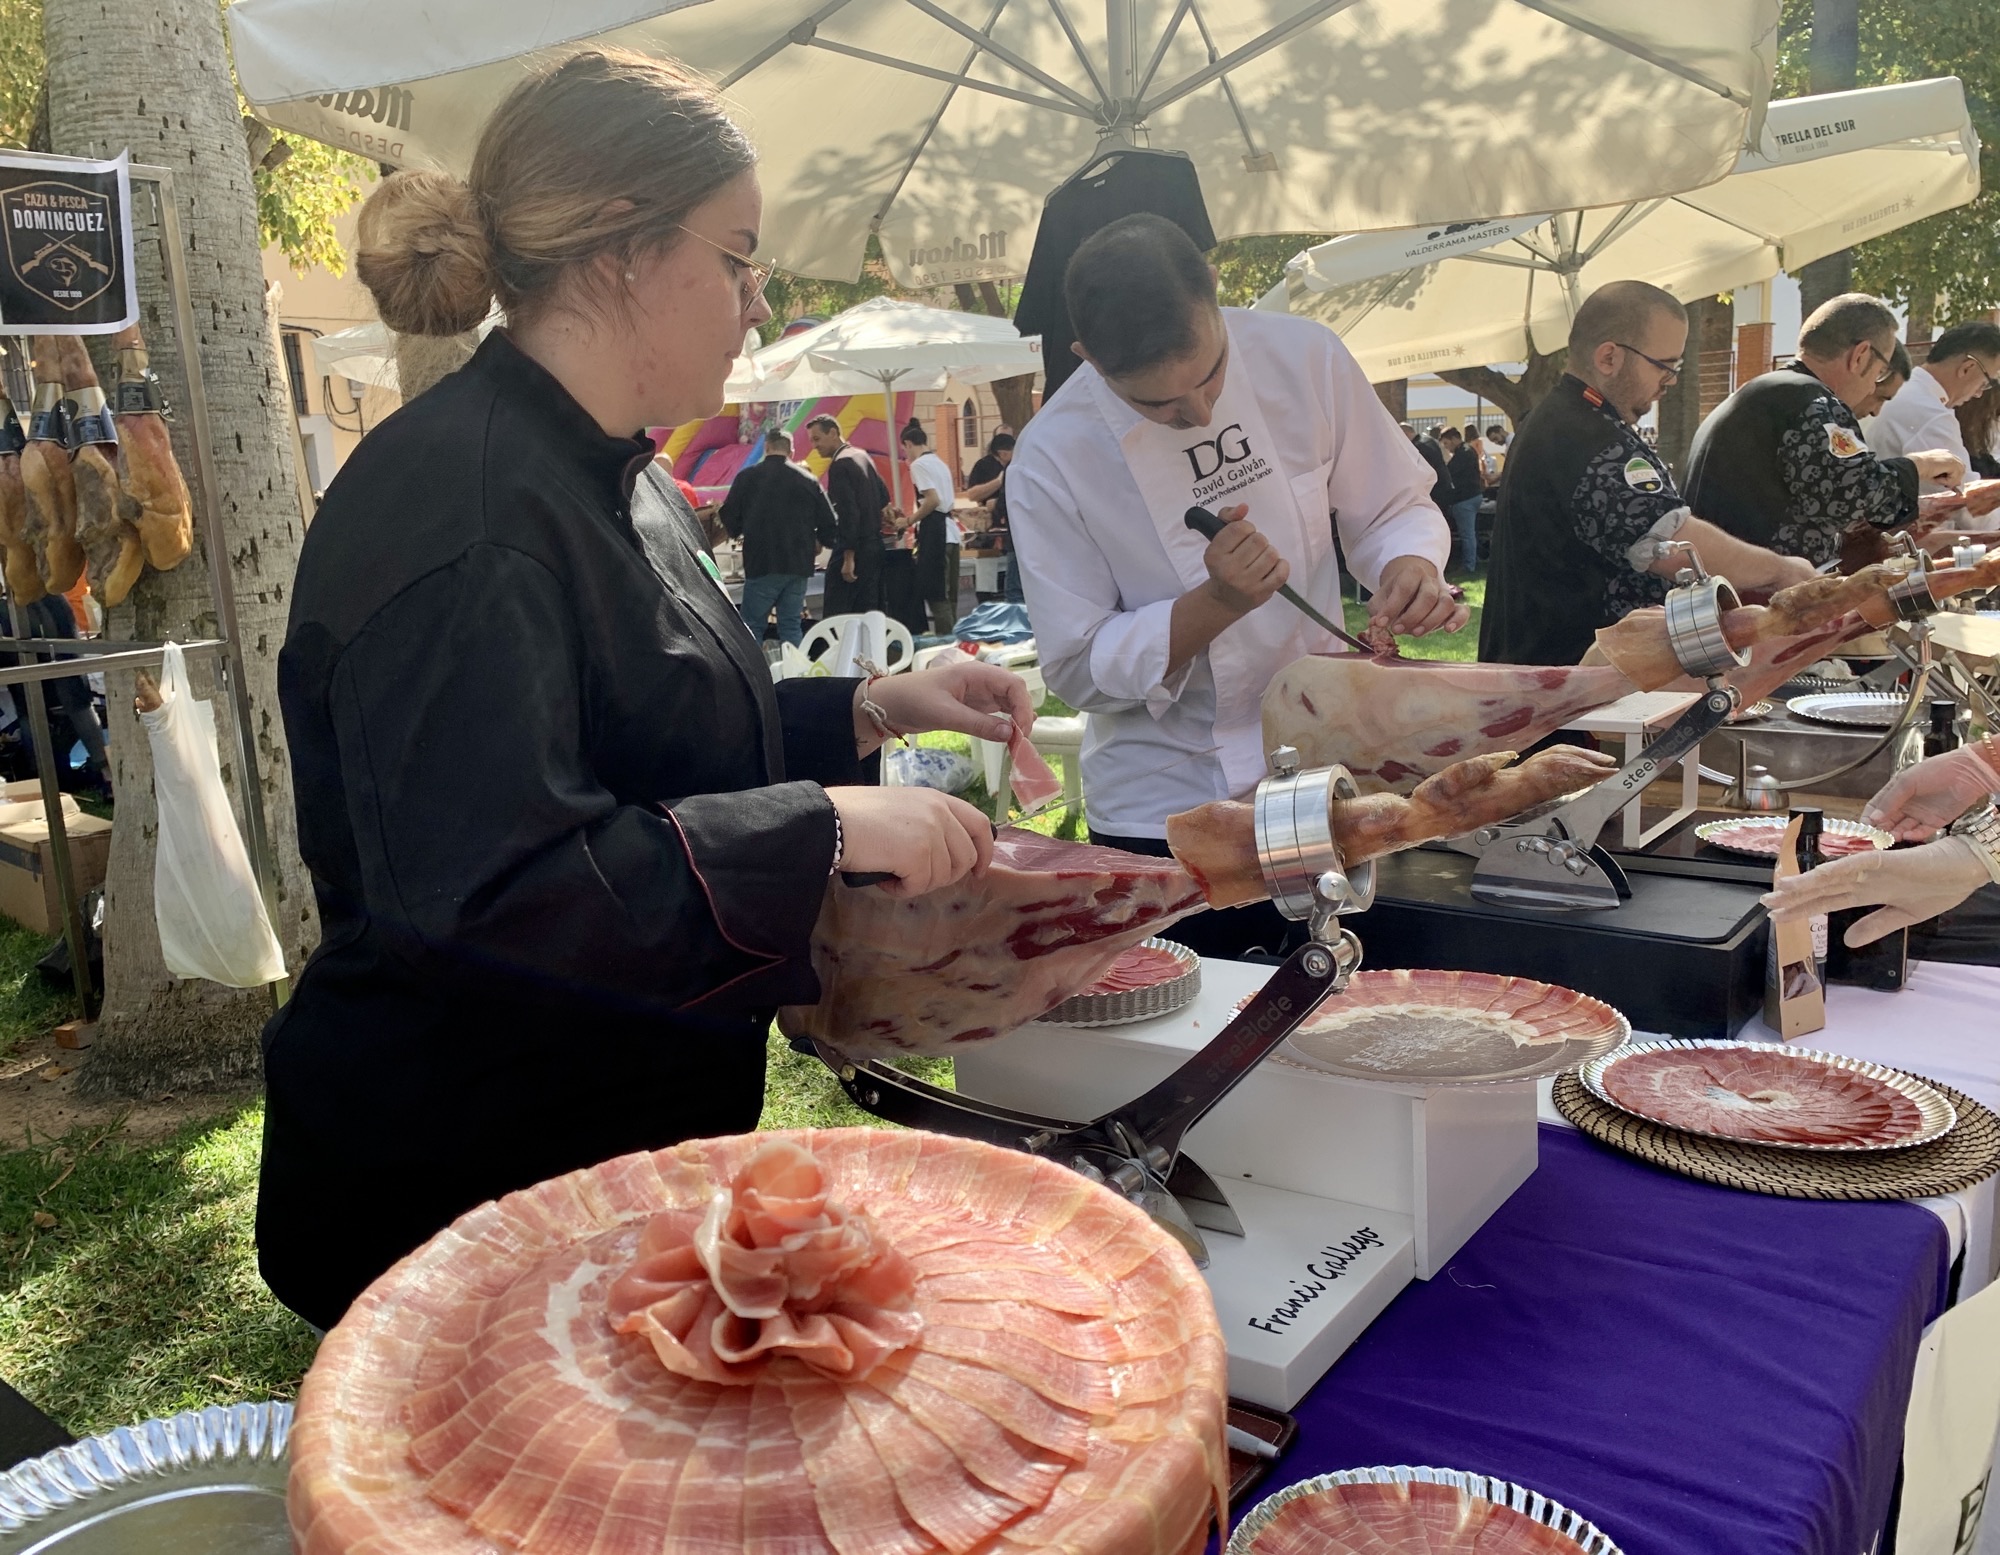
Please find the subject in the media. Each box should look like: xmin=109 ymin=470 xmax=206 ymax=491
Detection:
xmin=1166 ymin=746 xmax=1618 ymax=907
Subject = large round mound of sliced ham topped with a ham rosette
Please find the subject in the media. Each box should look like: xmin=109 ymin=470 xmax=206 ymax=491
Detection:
xmin=288 ymin=1129 xmax=1226 ymax=1555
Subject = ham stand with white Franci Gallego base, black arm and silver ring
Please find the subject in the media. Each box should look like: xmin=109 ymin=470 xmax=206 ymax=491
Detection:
xmin=810 ymin=748 xmax=1512 ymax=1409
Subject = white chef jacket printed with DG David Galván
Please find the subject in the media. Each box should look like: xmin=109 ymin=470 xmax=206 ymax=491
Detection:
xmin=1006 ymin=308 xmax=1450 ymax=837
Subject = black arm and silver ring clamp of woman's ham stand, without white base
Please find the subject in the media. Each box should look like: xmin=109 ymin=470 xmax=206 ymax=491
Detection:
xmin=810 ymin=746 xmax=1374 ymax=1267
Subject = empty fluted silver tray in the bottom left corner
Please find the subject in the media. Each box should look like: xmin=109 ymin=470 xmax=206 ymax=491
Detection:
xmin=0 ymin=1403 xmax=292 ymax=1555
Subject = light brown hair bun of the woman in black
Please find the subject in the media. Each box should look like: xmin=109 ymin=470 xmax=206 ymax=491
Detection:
xmin=354 ymin=172 xmax=494 ymax=336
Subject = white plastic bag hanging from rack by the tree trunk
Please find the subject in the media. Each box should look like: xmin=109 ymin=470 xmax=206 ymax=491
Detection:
xmin=140 ymin=644 xmax=284 ymax=987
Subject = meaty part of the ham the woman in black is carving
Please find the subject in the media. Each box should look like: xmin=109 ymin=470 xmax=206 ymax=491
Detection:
xmin=778 ymin=827 xmax=1208 ymax=1057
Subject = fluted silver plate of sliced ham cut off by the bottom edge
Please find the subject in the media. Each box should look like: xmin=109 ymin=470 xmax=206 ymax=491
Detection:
xmin=1226 ymin=1465 xmax=1620 ymax=1555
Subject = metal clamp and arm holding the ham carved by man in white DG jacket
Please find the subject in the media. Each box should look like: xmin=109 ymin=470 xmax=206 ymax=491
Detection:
xmin=1450 ymin=540 xmax=1750 ymax=911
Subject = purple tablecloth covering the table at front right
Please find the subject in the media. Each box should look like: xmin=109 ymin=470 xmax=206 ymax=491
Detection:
xmin=1262 ymin=1125 xmax=1948 ymax=1555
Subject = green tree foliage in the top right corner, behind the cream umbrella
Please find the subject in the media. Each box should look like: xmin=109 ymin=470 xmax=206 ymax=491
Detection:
xmin=1774 ymin=0 xmax=2000 ymax=322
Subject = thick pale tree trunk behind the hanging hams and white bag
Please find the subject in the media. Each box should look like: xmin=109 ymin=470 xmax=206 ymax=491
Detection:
xmin=44 ymin=0 xmax=318 ymax=1095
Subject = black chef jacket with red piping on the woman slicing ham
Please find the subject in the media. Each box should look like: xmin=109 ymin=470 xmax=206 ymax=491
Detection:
xmin=258 ymin=330 xmax=864 ymax=1325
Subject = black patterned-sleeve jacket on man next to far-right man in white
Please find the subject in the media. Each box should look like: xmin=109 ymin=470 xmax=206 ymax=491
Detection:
xmin=1688 ymin=362 xmax=1916 ymax=564
